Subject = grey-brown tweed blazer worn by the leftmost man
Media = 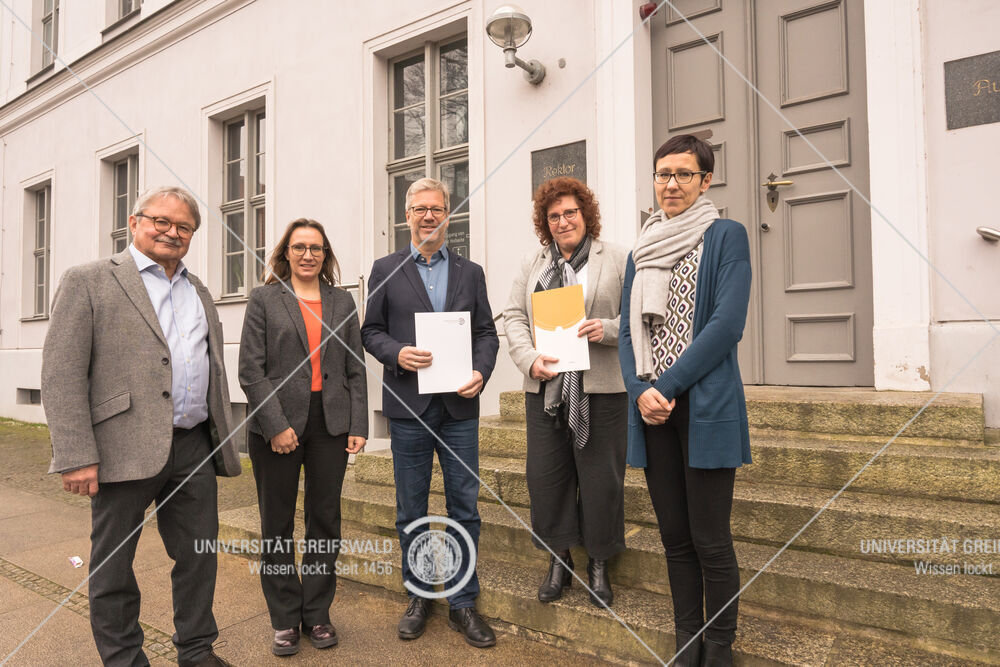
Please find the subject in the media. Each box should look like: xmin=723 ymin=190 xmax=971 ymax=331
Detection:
xmin=42 ymin=249 xmax=242 ymax=482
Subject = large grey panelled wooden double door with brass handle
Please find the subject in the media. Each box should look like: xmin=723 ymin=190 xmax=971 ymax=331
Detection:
xmin=651 ymin=0 xmax=874 ymax=386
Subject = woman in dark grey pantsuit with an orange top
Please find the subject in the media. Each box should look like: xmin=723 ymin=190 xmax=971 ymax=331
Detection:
xmin=239 ymin=218 xmax=368 ymax=655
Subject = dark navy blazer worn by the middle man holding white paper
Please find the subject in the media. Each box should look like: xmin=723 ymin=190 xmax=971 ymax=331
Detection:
xmin=361 ymin=246 xmax=500 ymax=419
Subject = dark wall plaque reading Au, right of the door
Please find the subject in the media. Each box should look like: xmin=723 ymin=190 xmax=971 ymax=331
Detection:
xmin=944 ymin=51 xmax=1000 ymax=130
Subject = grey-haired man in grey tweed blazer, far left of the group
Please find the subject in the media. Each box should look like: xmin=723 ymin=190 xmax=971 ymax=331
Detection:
xmin=42 ymin=186 xmax=241 ymax=665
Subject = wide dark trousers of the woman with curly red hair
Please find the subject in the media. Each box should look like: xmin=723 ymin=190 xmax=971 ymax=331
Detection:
xmin=524 ymin=384 xmax=628 ymax=560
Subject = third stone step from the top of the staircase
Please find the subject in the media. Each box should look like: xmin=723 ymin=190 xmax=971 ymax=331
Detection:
xmin=354 ymin=451 xmax=1000 ymax=575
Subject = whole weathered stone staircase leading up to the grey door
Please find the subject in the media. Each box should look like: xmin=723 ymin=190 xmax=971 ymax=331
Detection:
xmin=226 ymin=387 xmax=1000 ymax=665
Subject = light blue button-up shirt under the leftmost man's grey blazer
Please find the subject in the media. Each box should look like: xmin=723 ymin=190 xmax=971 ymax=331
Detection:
xmin=128 ymin=245 xmax=209 ymax=428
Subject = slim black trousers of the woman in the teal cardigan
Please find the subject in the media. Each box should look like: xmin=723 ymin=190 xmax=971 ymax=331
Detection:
xmin=645 ymin=393 xmax=740 ymax=644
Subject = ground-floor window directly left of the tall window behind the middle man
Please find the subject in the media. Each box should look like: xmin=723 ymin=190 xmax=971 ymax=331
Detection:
xmin=221 ymin=109 xmax=267 ymax=296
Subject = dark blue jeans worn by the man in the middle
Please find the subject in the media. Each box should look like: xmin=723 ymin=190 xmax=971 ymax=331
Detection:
xmin=389 ymin=396 xmax=480 ymax=609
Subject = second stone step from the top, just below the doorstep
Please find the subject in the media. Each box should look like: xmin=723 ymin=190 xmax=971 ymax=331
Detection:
xmin=479 ymin=417 xmax=1000 ymax=500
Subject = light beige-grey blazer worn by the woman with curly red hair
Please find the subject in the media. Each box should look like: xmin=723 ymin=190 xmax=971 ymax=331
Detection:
xmin=503 ymin=239 xmax=626 ymax=394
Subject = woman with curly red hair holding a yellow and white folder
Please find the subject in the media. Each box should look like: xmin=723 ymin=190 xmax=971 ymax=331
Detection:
xmin=503 ymin=178 xmax=627 ymax=607
